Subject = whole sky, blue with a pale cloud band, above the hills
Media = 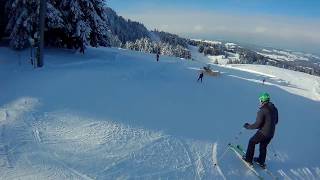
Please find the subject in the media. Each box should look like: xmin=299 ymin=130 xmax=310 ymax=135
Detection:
xmin=107 ymin=0 xmax=320 ymax=54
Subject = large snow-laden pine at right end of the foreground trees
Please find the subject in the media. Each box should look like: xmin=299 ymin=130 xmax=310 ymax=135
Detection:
xmin=60 ymin=0 xmax=104 ymax=46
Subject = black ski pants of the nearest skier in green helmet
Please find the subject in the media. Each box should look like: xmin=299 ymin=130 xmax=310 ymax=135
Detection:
xmin=246 ymin=131 xmax=272 ymax=164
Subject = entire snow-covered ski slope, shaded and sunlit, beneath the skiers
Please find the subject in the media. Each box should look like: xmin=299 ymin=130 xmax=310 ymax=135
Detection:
xmin=0 ymin=48 xmax=320 ymax=179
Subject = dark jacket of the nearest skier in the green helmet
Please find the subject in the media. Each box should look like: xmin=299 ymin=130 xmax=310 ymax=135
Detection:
xmin=248 ymin=102 xmax=278 ymax=138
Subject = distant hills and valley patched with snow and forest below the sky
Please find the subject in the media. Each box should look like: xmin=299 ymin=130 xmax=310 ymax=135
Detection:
xmin=189 ymin=40 xmax=320 ymax=76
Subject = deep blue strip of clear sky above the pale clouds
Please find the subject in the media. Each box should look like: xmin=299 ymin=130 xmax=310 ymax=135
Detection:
xmin=107 ymin=0 xmax=320 ymax=18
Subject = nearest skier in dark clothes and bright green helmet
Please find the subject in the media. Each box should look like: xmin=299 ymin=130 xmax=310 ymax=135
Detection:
xmin=243 ymin=93 xmax=278 ymax=168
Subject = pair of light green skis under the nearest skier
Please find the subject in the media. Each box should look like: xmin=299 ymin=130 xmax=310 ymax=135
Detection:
xmin=228 ymin=143 xmax=278 ymax=180
